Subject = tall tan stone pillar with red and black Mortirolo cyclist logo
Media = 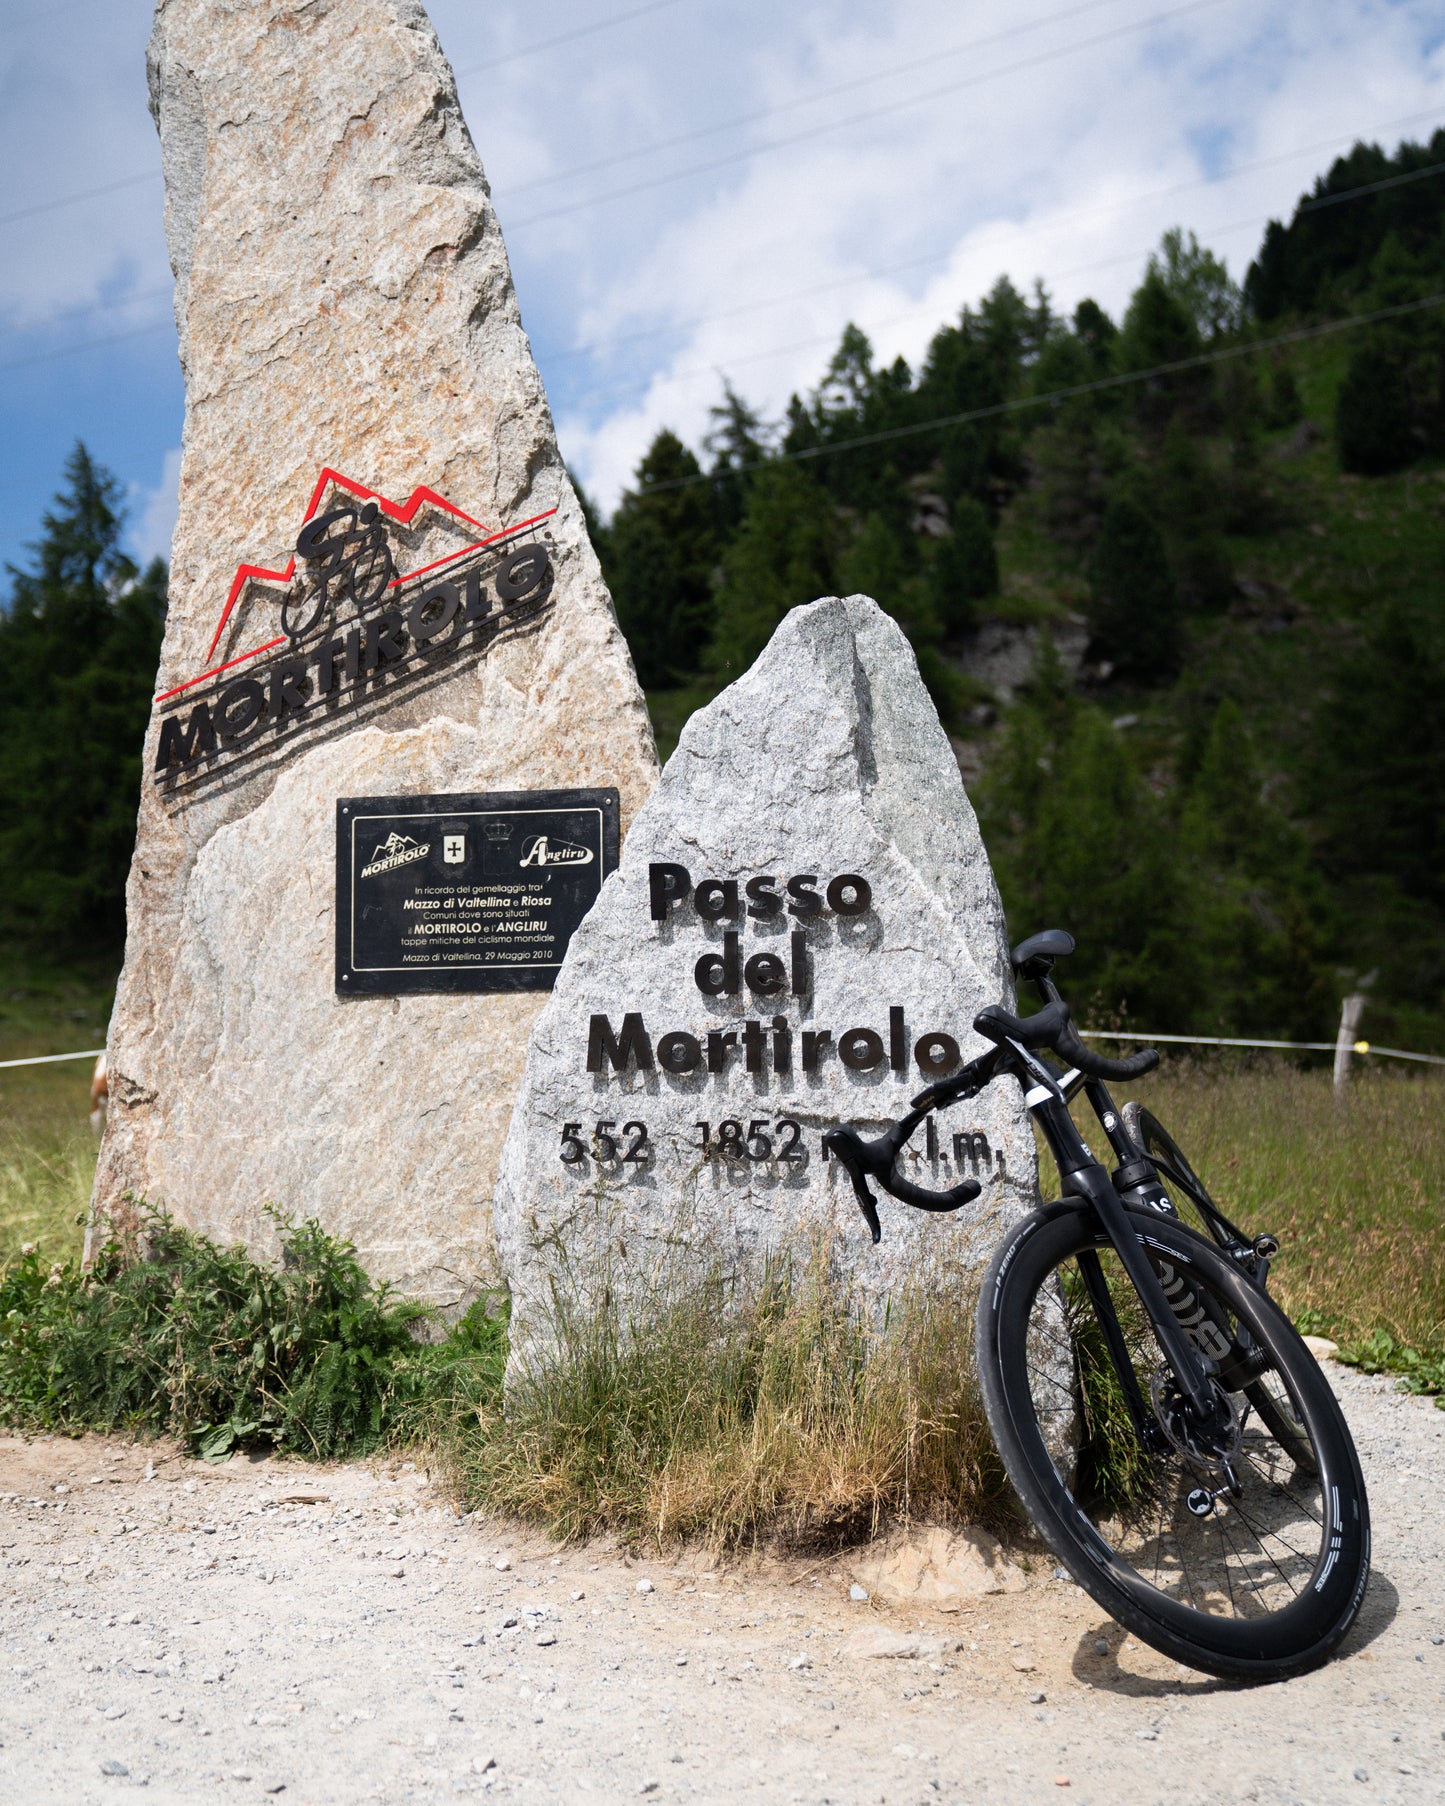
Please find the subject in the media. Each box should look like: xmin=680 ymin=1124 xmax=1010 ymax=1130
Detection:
xmin=92 ymin=0 xmax=656 ymax=1299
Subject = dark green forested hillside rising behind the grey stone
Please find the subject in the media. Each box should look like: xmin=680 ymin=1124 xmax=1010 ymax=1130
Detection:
xmin=598 ymin=130 xmax=1445 ymax=1051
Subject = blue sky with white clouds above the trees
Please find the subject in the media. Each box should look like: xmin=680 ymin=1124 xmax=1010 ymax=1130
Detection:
xmin=0 ymin=0 xmax=1445 ymax=577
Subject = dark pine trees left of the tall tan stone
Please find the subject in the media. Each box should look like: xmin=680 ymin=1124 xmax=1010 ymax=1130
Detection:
xmin=0 ymin=444 xmax=166 ymax=954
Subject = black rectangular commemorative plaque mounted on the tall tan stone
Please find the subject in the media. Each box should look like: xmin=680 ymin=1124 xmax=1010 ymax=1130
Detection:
xmin=336 ymin=789 xmax=618 ymax=997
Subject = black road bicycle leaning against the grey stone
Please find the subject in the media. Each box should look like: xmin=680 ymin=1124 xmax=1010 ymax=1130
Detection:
xmin=824 ymin=928 xmax=1369 ymax=1680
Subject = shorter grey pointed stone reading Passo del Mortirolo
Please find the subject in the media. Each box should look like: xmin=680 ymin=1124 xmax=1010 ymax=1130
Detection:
xmin=495 ymin=596 xmax=1037 ymax=1358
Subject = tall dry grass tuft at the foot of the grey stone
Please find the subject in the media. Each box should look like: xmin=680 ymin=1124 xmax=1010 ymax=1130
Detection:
xmin=434 ymin=1261 xmax=1006 ymax=1548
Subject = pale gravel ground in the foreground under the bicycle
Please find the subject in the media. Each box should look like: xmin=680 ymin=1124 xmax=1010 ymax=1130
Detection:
xmin=0 ymin=1367 xmax=1445 ymax=1806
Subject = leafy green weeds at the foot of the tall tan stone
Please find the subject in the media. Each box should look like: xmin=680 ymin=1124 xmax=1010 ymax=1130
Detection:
xmin=0 ymin=1215 xmax=504 ymax=1459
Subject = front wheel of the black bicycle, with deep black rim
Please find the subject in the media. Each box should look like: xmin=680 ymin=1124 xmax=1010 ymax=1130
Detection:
xmin=975 ymin=1201 xmax=1369 ymax=1681
